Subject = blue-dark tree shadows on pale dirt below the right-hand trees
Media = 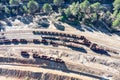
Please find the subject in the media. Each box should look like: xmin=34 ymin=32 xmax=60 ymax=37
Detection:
xmin=68 ymin=22 xmax=120 ymax=36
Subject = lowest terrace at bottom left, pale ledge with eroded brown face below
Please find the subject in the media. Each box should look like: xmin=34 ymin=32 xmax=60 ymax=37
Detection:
xmin=0 ymin=65 xmax=89 ymax=80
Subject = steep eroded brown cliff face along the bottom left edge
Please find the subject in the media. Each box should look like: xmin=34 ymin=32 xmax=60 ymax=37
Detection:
xmin=0 ymin=69 xmax=81 ymax=80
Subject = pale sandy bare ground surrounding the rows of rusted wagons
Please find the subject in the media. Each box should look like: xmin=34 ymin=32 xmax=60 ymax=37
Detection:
xmin=0 ymin=15 xmax=120 ymax=80
